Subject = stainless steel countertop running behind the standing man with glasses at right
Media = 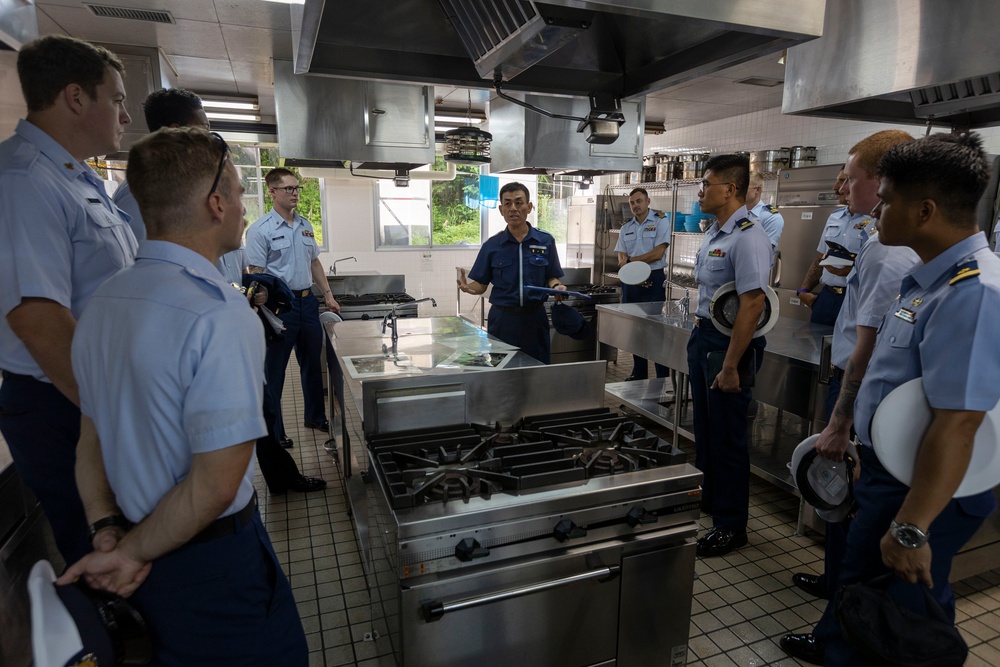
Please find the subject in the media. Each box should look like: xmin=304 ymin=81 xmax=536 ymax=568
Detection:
xmin=597 ymin=302 xmax=833 ymax=368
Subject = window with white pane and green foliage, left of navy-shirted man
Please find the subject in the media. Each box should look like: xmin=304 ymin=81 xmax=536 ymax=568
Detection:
xmin=376 ymin=158 xmax=483 ymax=247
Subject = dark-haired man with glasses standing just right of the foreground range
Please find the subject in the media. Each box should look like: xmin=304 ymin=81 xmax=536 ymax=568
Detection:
xmin=687 ymin=155 xmax=771 ymax=557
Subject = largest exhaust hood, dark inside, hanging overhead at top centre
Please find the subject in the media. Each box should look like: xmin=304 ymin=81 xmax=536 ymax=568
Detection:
xmin=293 ymin=0 xmax=826 ymax=98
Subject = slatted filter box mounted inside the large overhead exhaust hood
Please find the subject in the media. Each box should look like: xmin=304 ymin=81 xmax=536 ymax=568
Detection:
xmin=438 ymin=0 xmax=593 ymax=81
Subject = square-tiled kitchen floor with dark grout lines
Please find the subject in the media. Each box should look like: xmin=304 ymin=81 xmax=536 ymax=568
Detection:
xmin=266 ymin=354 xmax=1000 ymax=667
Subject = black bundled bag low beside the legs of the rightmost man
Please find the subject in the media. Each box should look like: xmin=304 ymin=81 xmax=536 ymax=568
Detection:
xmin=837 ymin=573 xmax=969 ymax=667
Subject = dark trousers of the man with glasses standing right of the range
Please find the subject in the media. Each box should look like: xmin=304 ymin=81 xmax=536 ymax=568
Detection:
xmin=687 ymin=319 xmax=765 ymax=532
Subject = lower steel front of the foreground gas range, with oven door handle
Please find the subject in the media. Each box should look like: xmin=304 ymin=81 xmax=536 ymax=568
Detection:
xmin=398 ymin=524 xmax=696 ymax=667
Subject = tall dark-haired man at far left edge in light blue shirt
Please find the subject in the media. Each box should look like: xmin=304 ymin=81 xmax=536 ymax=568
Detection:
xmin=0 ymin=35 xmax=136 ymax=562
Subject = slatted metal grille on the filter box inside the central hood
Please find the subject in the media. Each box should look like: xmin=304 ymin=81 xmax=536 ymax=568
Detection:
xmin=439 ymin=0 xmax=538 ymax=60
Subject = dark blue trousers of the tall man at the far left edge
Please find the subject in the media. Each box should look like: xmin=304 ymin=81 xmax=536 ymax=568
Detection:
xmin=0 ymin=374 xmax=91 ymax=564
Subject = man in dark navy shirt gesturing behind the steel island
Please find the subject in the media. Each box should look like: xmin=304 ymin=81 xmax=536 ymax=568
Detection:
xmin=458 ymin=183 xmax=566 ymax=364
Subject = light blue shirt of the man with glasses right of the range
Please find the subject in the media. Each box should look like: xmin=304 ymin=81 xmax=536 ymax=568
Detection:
xmin=694 ymin=206 xmax=771 ymax=317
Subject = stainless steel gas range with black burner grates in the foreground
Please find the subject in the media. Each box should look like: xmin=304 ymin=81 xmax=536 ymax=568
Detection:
xmin=367 ymin=408 xmax=702 ymax=667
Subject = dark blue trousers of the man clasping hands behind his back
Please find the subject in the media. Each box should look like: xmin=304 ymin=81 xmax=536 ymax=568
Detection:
xmin=130 ymin=512 xmax=309 ymax=667
